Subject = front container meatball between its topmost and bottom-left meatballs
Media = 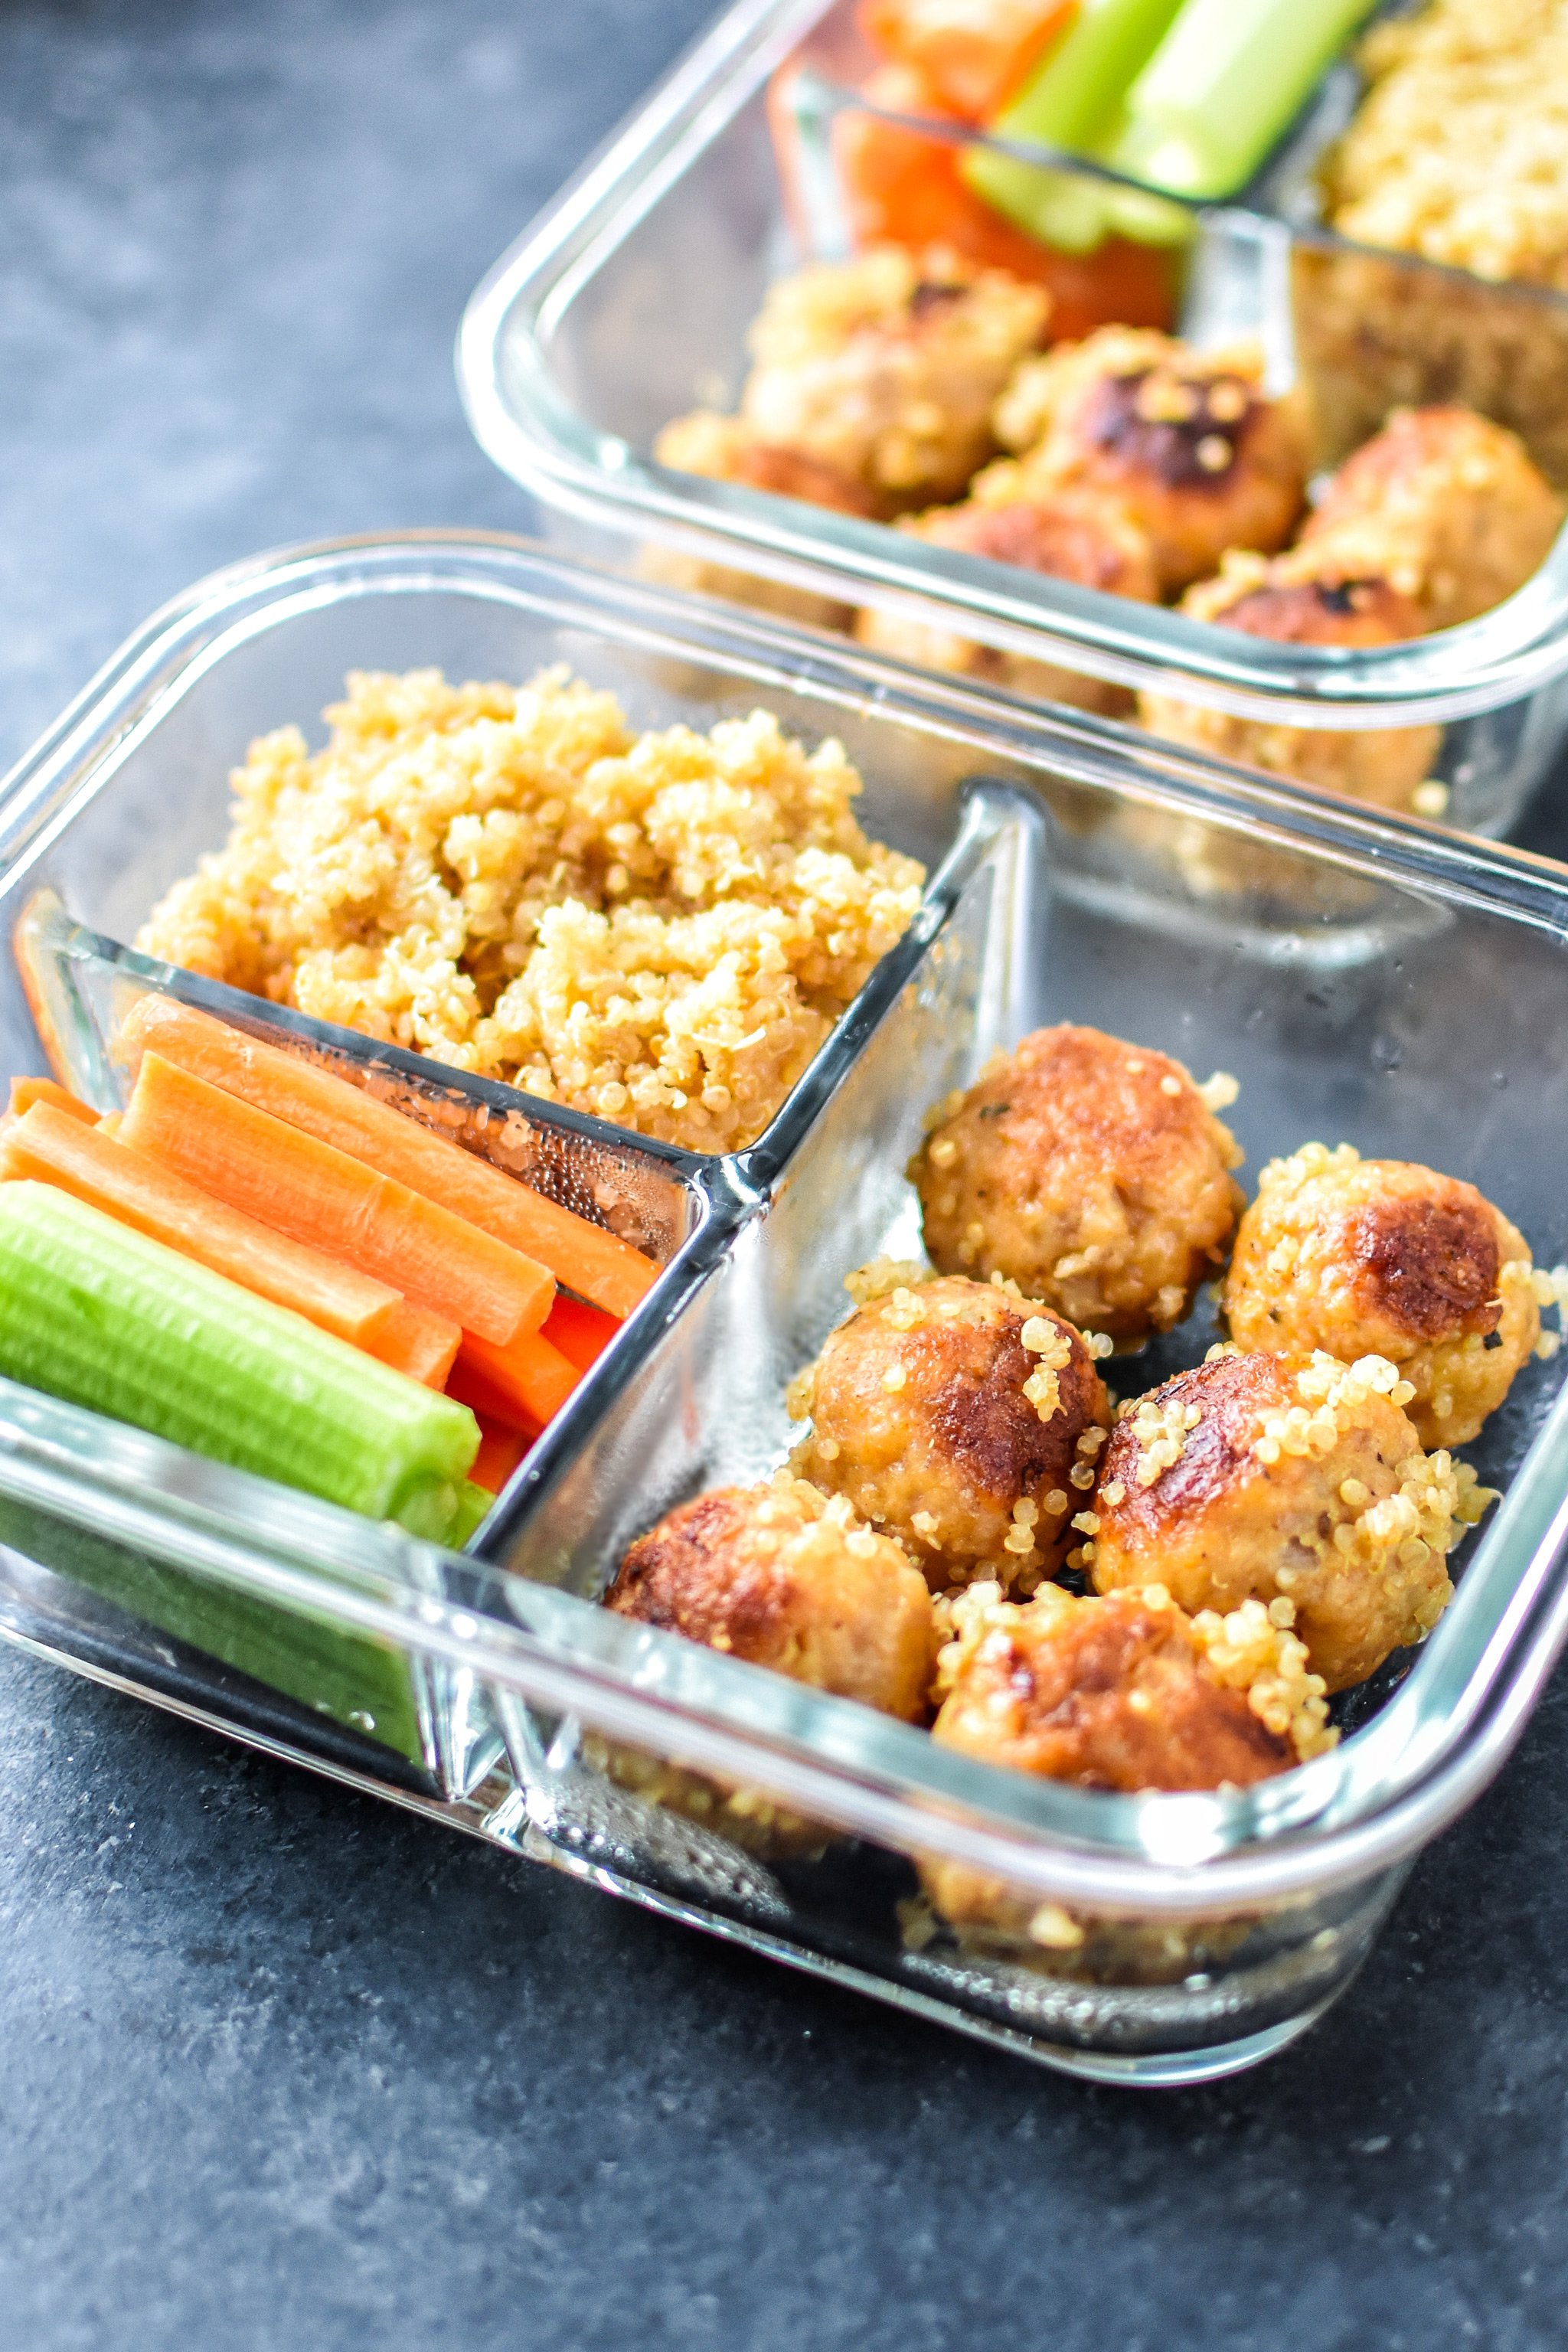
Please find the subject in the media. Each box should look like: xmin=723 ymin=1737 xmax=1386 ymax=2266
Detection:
xmin=790 ymin=1277 xmax=1109 ymax=1590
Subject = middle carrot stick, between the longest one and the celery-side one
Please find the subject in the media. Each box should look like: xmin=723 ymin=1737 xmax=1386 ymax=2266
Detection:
xmin=120 ymin=1054 xmax=555 ymax=1345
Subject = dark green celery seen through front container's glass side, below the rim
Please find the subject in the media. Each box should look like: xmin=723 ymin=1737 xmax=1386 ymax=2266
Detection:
xmin=0 ymin=1496 xmax=426 ymax=1766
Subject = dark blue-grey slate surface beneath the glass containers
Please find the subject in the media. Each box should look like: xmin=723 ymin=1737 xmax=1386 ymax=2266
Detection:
xmin=0 ymin=0 xmax=1568 ymax=2352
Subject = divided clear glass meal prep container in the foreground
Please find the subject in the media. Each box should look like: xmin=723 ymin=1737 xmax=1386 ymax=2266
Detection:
xmin=0 ymin=534 xmax=1568 ymax=2084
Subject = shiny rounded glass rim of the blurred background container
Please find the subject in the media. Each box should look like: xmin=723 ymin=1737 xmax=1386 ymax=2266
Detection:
xmin=456 ymin=0 xmax=1568 ymax=729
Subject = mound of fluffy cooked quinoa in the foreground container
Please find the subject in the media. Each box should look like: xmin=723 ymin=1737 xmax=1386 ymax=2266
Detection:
xmin=136 ymin=668 xmax=924 ymax=1152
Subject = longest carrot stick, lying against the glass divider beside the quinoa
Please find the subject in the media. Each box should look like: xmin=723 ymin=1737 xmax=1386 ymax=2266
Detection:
xmin=118 ymin=995 xmax=658 ymax=1315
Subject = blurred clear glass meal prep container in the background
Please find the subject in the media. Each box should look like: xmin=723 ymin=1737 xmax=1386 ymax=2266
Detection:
xmin=459 ymin=0 xmax=1568 ymax=832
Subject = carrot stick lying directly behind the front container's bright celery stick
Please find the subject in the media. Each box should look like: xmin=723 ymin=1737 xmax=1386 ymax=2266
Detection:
xmin=0 ymin=1101 xmax=404 ymax=1354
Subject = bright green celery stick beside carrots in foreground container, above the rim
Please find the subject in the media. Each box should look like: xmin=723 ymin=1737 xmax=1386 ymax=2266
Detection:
xmin=0 ymin=1181 xmax=479 ymax=1538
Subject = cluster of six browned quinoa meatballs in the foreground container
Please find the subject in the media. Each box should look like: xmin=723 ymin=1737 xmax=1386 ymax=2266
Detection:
xmin=609 ymin=1025 xmax=1542 ymax=1981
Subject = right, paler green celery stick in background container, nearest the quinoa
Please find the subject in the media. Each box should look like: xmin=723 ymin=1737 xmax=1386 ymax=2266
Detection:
xmin=1105 ymin=0 xmax=1373 ymax=198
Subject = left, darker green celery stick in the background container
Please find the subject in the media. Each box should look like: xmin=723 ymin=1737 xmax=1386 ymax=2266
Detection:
xmin=962 ymin=0 xmax=1180 ymax=254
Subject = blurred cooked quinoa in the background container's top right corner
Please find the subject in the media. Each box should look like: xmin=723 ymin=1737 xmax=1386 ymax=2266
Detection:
xmin=1326 ymin=0 xmax=1568 ymax=287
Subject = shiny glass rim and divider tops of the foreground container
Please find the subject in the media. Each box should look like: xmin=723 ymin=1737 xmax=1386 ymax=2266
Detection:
xmin=0 ymin=531 xmax=1568 ymax=1915
